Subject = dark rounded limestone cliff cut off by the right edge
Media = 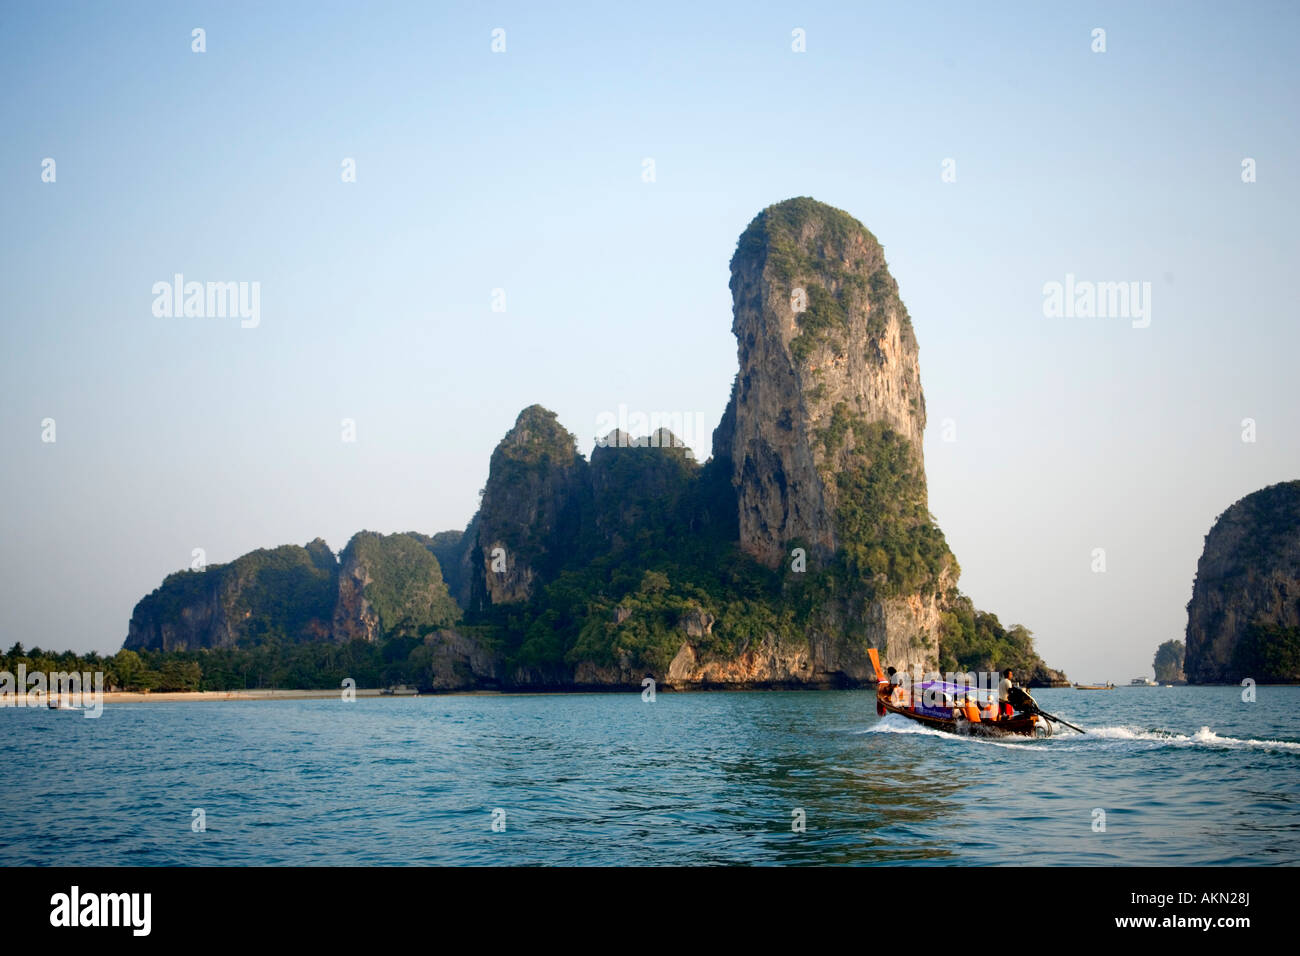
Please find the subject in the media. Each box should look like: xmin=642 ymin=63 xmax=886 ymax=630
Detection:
xmin=1184 ymin=481 xmax=1300 ymax=684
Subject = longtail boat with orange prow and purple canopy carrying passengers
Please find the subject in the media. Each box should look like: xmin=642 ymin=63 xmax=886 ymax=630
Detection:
xmin=867 ymin=648 xmax=1052 ymax=737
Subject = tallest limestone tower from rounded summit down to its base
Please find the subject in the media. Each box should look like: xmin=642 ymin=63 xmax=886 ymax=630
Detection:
xmin=714 ymin=199 xmax=958 ymax=674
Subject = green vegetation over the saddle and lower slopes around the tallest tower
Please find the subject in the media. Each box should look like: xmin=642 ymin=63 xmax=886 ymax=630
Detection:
xmin=464 ymin=425 xmax=1061 ymax=683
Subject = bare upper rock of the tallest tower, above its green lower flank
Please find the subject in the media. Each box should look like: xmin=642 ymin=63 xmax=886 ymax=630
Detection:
xmin=714 ymin=198 xmax=927 ymax=567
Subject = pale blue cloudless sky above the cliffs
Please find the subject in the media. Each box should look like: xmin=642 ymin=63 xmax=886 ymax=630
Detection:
xmin=0 ymin=3 xmax=1300 ymax=680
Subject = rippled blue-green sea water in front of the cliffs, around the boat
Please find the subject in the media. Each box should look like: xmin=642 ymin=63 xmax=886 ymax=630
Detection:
xmin=0 ymin=687 xmax=1300 ymax=866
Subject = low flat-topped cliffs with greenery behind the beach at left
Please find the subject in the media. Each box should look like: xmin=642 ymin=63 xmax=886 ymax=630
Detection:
xmin=118 ymin=532 xmax=460 ymax=691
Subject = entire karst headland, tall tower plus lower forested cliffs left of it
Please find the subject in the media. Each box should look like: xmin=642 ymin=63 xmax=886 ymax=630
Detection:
xmin=114 ymin=198 xmax=1076 ymax=691
